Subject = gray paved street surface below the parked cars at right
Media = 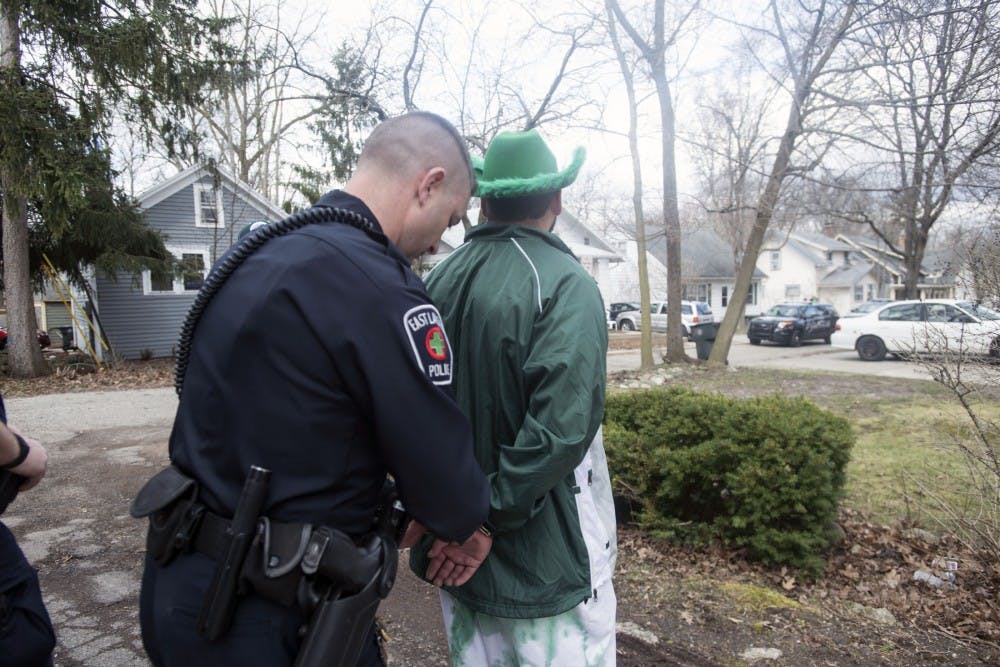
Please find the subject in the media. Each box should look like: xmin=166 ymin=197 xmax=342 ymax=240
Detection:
xmin=608 ymin=333 xmax=930 ymax=379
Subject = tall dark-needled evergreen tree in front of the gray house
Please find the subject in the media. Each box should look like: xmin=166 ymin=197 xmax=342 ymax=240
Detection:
xmin=0 ymin=0 xmax=231 ymax=377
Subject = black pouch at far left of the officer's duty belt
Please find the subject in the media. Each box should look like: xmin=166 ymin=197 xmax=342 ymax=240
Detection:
xmin=129 ymin=466 xmax=205 ymax=565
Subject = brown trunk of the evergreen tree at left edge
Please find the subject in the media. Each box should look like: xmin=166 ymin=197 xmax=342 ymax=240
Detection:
xmin=0 ymin=0 xmax=45 ymax=377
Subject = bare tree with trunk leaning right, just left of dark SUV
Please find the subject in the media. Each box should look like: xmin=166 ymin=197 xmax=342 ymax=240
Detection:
xmin=709 ymin=0 xmax=859 ymax=364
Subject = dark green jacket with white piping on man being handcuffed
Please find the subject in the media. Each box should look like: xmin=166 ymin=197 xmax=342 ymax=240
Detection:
xmin=410 ymin=223 xmax=617 ymax=618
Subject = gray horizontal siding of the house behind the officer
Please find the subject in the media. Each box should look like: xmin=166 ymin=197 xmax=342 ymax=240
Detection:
xmin=96 ymin=176 xmax=281 ymax=359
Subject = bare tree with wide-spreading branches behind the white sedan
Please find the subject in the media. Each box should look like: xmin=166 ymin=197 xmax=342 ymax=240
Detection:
xmin=832 ymin=0 xmax=1000 ymax=298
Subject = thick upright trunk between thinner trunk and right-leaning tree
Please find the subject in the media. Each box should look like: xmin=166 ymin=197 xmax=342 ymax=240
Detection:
xmin=653 ymin=62 xmax=687 ymax=362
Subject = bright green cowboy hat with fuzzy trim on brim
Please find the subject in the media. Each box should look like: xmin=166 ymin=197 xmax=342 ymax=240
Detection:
xmin=473 ymin=130 xmax=586 ymax=199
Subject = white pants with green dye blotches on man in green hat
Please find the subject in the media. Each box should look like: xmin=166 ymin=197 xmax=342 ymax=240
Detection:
xmin=441 ymin=580 xmax=617 ymax=667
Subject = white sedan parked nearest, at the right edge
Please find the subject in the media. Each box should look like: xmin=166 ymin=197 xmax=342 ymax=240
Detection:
xmin=833 ymin=299 xmax=1000 ymax=361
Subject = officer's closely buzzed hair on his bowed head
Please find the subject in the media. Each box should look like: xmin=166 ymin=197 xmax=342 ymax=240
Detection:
xmin=358 ymin=111 xmax=476 ymax=196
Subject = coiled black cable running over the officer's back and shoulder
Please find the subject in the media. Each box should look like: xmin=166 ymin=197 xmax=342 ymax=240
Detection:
xmin=174 ymin=206 xmax=389 ymax=397
